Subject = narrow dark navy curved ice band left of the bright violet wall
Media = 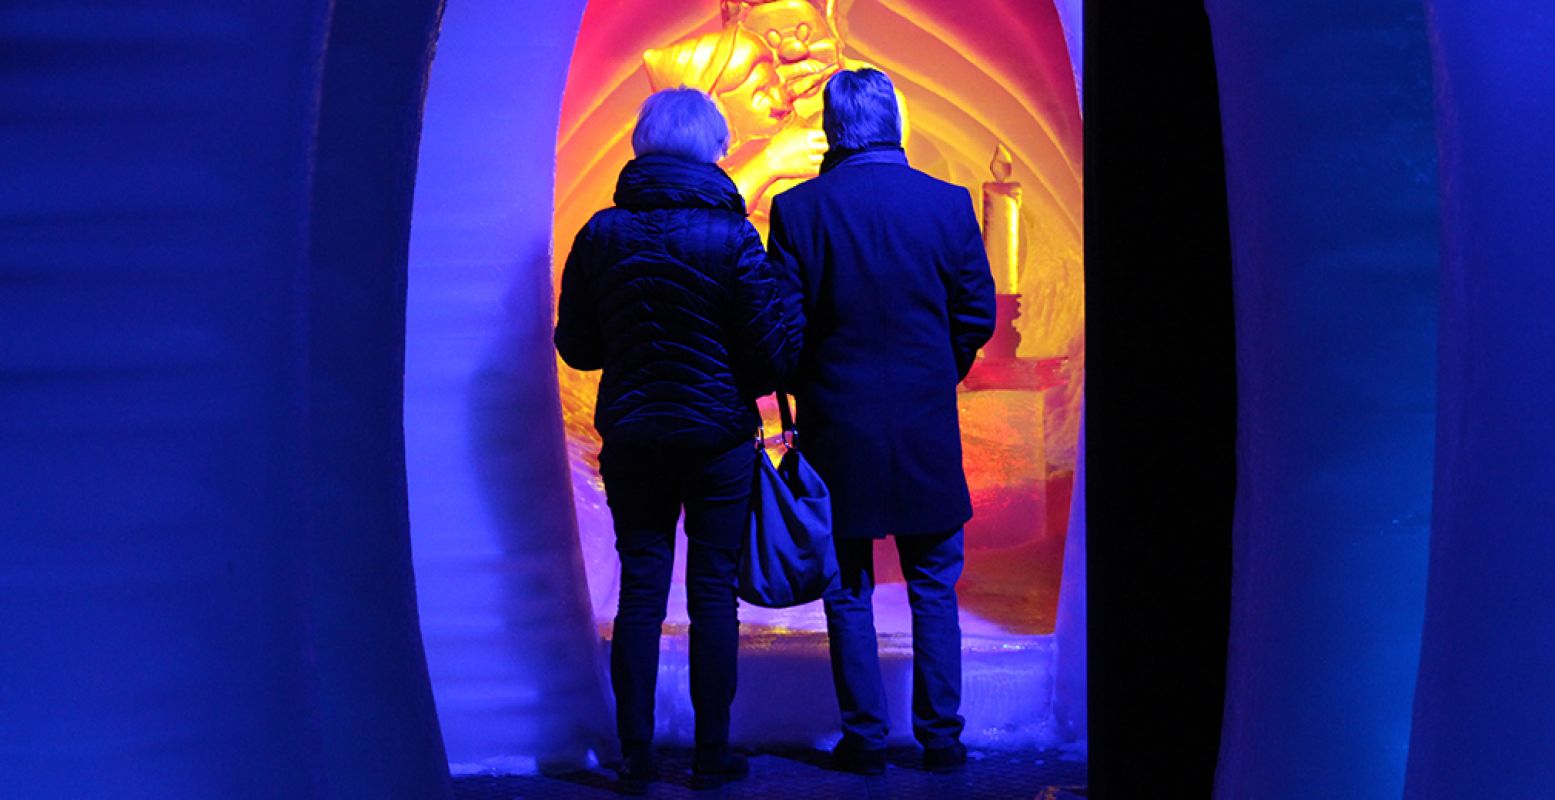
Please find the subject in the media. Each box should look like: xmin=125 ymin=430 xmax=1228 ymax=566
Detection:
xmin=308 ymin=0 xmax=449 ymax=800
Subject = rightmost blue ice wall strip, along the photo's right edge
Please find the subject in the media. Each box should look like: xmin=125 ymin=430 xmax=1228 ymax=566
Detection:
xmin=1406 ymin=0 xmax=1555 ymax=790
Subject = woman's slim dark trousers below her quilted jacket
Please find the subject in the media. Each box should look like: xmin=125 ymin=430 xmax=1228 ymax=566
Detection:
xmin=599 ymin=442 xmax=756 ymax=747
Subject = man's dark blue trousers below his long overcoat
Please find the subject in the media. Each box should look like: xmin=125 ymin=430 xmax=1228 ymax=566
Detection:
xmin=826 ymin=531 xmax=966 ymax=749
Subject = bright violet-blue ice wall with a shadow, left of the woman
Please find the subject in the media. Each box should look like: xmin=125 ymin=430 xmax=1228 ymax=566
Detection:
xmin=404 ymin=0 xmax=614 ymax=769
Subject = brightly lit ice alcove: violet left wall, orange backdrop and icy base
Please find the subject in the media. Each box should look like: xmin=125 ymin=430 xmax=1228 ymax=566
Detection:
xmin=406 ymin=0 xmax=1084 ymax=763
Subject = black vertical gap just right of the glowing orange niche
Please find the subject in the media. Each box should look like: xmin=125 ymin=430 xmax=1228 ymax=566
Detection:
xmin=1085 ymin=2 xmax=1236 ymax=798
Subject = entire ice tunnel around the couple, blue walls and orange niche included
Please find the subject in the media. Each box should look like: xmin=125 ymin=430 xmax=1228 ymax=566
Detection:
xmin=15 ymin=0 xmax=1555 ymax=800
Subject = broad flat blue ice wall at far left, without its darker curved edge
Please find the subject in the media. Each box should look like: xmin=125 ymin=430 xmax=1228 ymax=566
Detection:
xmin=0 ymin=0 xmax=330 ymax=800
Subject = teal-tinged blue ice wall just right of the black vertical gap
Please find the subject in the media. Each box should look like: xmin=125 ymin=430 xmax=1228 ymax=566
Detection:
xmin=1207 ymin=0 xmax=1438 ymax=800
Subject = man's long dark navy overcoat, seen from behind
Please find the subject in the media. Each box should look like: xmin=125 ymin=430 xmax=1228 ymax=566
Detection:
xmin=768 ymin=146 xmax=994 ymax=537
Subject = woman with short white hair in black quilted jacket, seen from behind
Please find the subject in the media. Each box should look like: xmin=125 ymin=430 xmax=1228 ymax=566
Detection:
xmin=555 ymin=87 xmax=795 ymax=792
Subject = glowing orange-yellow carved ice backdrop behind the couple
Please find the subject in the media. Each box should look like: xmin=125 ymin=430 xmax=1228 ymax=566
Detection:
xmin=554 ymin=0 xmax=1084 ymax=632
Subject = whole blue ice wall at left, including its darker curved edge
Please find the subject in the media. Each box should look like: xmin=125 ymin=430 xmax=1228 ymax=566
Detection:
xmin=0 ymin=0 xmax=448 ymax=800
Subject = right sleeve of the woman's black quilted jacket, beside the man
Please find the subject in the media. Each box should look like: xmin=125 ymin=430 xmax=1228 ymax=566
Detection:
xmin=734 ymin=219 xmax=793 ymax=397
